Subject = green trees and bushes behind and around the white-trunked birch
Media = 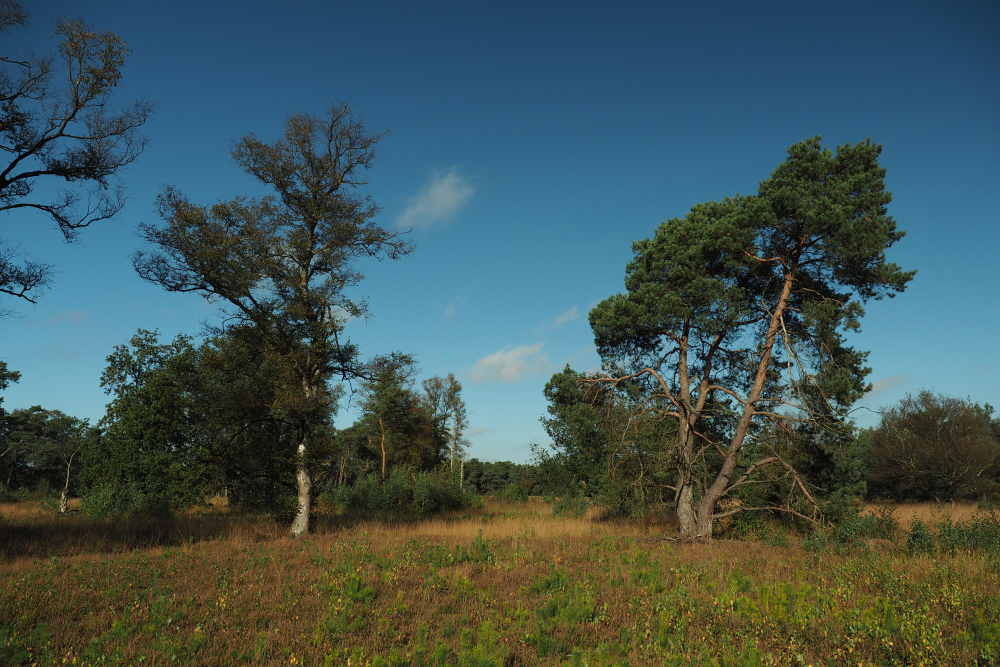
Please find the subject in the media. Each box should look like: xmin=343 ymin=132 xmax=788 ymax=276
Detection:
xmin=0 ymin=330 xmax=555 ymax=519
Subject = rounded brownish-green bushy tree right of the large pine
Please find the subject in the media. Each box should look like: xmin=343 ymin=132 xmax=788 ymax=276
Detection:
xmin=865 ymin=390 xmax=1000 ymax=501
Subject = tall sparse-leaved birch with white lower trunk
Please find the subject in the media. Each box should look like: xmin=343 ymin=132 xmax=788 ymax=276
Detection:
xmin=133 ymin=105 xmax=412 ymax=536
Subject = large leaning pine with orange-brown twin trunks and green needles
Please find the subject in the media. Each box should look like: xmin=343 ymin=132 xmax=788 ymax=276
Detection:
xmin=590 ymin=137 xmax=913 ymax=539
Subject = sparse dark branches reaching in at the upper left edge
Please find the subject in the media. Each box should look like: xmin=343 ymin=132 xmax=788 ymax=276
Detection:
xmin=0 ymin=0 xmax=153 ymax=312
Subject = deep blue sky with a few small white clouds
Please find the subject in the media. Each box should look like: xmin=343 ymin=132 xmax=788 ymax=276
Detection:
xmin=0 ymin=0 xmax=1000 ymax=461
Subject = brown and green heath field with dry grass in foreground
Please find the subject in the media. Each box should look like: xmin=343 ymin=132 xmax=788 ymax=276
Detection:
xmin=0 ymin=500 xmax=1000 ymax=667
